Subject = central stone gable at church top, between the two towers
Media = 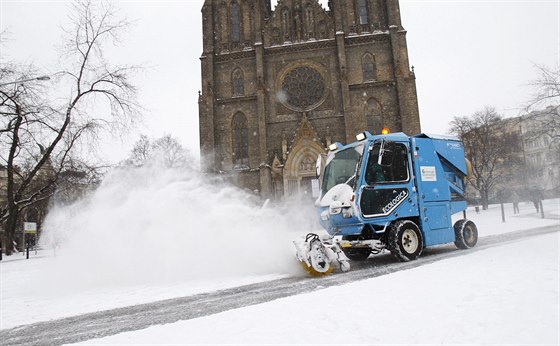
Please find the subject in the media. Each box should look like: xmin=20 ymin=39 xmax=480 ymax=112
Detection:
xmin=265 ymin=0 xmax=334 ymax=46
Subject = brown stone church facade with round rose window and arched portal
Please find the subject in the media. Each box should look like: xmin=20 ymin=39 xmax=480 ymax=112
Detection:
xmin=199 ymin=0 xmax=420 ymax=199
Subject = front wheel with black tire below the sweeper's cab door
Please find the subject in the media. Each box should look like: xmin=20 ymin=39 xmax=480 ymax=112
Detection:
xmin=387 ymin=220 xmax=424 ymax=262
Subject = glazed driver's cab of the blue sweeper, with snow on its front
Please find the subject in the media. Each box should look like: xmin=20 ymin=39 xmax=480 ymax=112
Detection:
xmin=316 ymin=132 xmax=417 ymax=236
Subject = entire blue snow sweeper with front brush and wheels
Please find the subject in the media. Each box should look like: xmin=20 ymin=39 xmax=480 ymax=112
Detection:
xmin=294 ymin=132 xmax=478 ymax=275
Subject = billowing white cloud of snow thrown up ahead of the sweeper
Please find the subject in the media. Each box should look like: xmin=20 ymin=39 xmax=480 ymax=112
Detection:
xmin=41 ymin=166 xmax=316 ymax=286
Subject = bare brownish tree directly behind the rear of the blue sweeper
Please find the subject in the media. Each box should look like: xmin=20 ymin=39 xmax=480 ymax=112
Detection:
xmin=451 ymin=107 xmax=519 ymax=209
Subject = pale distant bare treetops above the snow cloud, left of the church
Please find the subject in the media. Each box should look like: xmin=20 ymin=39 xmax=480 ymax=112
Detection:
xmin=124 ymin=134 xmax=194 ymax=168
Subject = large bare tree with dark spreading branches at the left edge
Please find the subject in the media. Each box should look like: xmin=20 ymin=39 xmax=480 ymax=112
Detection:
xmin=0 ymin=1 xmax=139 ymax=254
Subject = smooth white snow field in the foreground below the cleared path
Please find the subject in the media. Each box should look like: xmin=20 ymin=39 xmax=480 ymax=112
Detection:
xmin=76 ymin=233 xmax=560 ymax=345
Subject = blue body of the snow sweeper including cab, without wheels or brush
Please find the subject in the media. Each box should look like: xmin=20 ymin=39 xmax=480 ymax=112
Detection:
xmin=315 ymin=132 xmax=468 ymax=247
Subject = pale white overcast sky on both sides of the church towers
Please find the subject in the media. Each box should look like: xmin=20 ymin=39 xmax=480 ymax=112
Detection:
xmin=0 ymin=0 xmax=560 ymax=160
